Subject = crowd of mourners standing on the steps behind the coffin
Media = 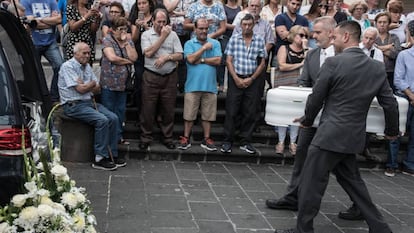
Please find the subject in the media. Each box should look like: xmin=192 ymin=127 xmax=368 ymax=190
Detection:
xmin=2 ymin=0 xmax=414 ymax=176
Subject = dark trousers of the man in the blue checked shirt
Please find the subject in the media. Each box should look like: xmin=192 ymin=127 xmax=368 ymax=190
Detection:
xmin=224 ymin=75 xmax=260 ymax=144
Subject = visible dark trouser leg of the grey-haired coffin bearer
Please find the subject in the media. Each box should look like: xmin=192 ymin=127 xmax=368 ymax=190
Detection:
xmin=284 ymin=127 xmax=316 ymax=205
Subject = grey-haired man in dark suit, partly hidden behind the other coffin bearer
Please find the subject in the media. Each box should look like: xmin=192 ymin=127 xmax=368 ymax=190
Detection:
xmin=266 ymin=16 xmax=336 ymax=210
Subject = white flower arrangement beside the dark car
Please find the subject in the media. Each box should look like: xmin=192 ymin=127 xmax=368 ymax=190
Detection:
xmin=0 ymin=104 xmax=96 ymax=233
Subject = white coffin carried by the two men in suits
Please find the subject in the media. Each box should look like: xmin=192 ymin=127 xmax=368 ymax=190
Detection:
xmin=265 ymin=86 xmax=408 ymax=135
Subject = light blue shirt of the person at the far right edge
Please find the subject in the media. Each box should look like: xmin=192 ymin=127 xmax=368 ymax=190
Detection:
xmin=394 ymin=47 xmax=414 ymax=92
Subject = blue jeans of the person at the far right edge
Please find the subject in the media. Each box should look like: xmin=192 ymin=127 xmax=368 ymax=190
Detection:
xmin=386 ymin=104 xmax=414 ymax=170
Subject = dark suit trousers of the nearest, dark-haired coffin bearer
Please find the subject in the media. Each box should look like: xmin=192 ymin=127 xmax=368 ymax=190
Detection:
xmin=296 ymin=145 xmax=391 ymax=233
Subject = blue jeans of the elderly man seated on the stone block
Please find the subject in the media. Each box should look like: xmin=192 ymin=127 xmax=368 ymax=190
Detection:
xmin=63 ymin=100 xmax=118 ymax=158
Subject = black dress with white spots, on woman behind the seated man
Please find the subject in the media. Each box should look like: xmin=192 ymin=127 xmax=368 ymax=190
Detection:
xmin=63 ymin=4 xmax=95 ymax=61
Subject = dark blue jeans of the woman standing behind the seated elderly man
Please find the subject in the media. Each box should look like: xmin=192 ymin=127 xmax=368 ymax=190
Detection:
xmin=101 ymin=88 xmax=127 ymax=141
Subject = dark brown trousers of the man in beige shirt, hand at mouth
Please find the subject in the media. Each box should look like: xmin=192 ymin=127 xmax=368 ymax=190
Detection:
xmin=140 ymin=68 xmax=178 ymax=143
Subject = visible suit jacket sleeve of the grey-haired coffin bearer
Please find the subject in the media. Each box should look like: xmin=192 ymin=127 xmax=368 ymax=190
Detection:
xmin=298 ymin=47 xmax=321 ymax=87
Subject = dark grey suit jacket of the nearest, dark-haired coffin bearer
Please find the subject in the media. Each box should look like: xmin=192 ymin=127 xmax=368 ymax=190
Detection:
xmin=301 ymin=47 xmax=399 ymax=154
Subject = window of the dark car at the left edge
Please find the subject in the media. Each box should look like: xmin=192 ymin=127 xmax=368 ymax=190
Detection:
xmin=0 ymin=49 xmax=16 ymax=125
